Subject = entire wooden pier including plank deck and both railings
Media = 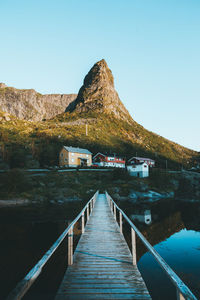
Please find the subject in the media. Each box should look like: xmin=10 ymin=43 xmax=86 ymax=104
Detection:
xmin=6 ymin=191 xmax=197 ymax=300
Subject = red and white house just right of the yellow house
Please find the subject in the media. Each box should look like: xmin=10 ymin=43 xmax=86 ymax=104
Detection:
xmin=93 ymin=152 xmax=125 ymax=168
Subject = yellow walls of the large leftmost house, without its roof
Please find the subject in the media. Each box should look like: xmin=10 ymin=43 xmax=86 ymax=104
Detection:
xmin=59 ymin=148 xmax=92 ymax=167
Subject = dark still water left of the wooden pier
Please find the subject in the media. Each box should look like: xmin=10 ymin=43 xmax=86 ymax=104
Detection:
xmin=0 ymin=202 xmax=84 ymax=300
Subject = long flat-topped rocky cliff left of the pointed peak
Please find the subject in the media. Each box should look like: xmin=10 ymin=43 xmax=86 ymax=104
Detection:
xmin=0 ymin=83 xmax=77 ymax=121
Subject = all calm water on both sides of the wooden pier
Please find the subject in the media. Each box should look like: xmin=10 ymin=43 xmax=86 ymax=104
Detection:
xmin=0 ymin=200 xmax=200 ymax=300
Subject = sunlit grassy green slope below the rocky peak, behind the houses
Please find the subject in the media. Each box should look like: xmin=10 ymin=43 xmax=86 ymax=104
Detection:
xmin=0 ymin=112 xmax=198 ymax=168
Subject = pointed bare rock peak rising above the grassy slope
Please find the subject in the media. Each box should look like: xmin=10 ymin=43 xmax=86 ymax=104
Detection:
xmin=66 ymin=59 xmax=132 ymax=121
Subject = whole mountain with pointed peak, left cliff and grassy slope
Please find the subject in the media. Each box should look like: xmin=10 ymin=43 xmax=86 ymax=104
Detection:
xmin=0 ymin=60 xmax=199 ymax=169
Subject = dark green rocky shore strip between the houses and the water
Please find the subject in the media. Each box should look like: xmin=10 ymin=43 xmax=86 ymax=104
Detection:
xmin=0 ymin=169 xmax=200 ymax=205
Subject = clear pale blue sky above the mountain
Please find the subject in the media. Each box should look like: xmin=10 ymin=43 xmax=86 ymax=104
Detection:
xmin=0 ymin=0 xmax=200 ymax=151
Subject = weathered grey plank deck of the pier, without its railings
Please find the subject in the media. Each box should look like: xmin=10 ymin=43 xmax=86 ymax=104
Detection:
xmin=56 ymin=194 xmax=151 ymax=300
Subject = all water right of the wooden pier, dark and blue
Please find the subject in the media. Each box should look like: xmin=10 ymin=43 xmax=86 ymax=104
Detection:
xmin=123 ymin=200 xmax=200 ymax=300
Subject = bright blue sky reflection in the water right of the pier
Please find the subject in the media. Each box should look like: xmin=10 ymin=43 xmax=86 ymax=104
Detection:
xmin=138 ymin=229 xmax=200 ymax=299
